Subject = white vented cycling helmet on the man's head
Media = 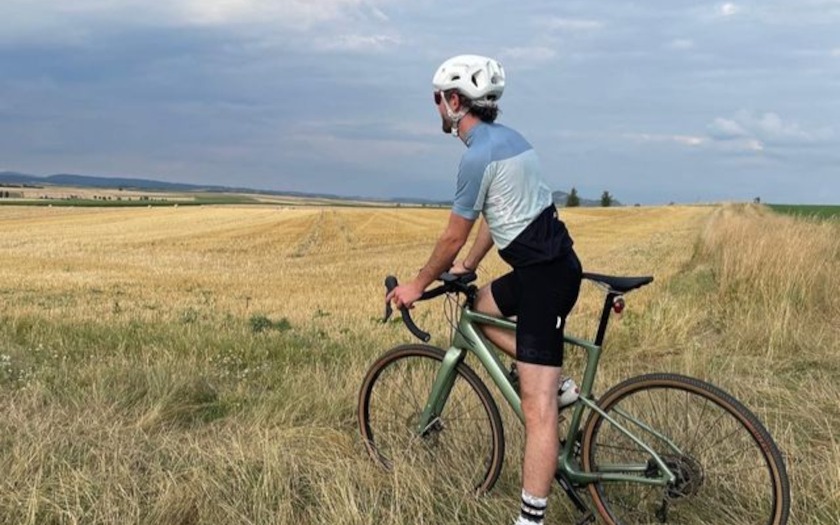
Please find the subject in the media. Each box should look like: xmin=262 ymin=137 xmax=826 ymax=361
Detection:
xmin=432 ymin=55 xmax=505 ymax=107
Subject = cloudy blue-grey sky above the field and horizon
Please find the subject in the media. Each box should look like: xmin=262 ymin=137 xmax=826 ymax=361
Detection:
xmin=0 ymin=0 xmax=840 ymax=204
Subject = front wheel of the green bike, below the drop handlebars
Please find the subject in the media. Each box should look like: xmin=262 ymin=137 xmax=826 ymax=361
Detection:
xmin=358 ymin=345 xmax=505 ymax=494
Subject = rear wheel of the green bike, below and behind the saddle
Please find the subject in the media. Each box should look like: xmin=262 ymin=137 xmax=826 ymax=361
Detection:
xmin=581 ymin=374 xmax=790 ymax=525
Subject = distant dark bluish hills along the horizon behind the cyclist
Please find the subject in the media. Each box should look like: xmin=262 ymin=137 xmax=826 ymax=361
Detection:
xmin=0 ymin=171 xmax=620 ymax=206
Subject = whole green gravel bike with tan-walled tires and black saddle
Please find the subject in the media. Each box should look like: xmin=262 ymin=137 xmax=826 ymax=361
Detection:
xmin=358 ymin=273 xmax=790 ymax=525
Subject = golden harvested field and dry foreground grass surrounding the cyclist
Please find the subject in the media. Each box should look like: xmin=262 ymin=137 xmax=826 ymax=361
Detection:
xmin=0 ymin=205 xmax=840 ymax=525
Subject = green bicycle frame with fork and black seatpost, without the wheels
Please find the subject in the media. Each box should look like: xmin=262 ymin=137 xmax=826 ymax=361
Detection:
xmin=417 ymin=292 xmax=681 ymax=486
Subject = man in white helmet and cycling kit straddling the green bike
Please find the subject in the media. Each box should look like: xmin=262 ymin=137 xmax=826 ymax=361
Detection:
xmin=386 ymin=55 xmax=581 ymax=525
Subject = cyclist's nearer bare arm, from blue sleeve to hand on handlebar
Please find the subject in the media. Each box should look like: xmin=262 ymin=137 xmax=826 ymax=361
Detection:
xmin=385 ymin=213 xmax=475 ymax=308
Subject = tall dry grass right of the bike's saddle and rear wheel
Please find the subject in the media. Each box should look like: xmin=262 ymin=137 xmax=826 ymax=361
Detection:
xmin=592 ymin=205 xmax=840 ymax=524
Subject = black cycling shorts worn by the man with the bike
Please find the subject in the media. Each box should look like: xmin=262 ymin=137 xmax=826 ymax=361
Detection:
xmin=490 ymin=251 xmax=582 ymax=366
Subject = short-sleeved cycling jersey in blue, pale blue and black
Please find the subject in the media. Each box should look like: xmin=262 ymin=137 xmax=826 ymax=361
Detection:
xmin=452 ymin=122 xmax=572 ymax=266
